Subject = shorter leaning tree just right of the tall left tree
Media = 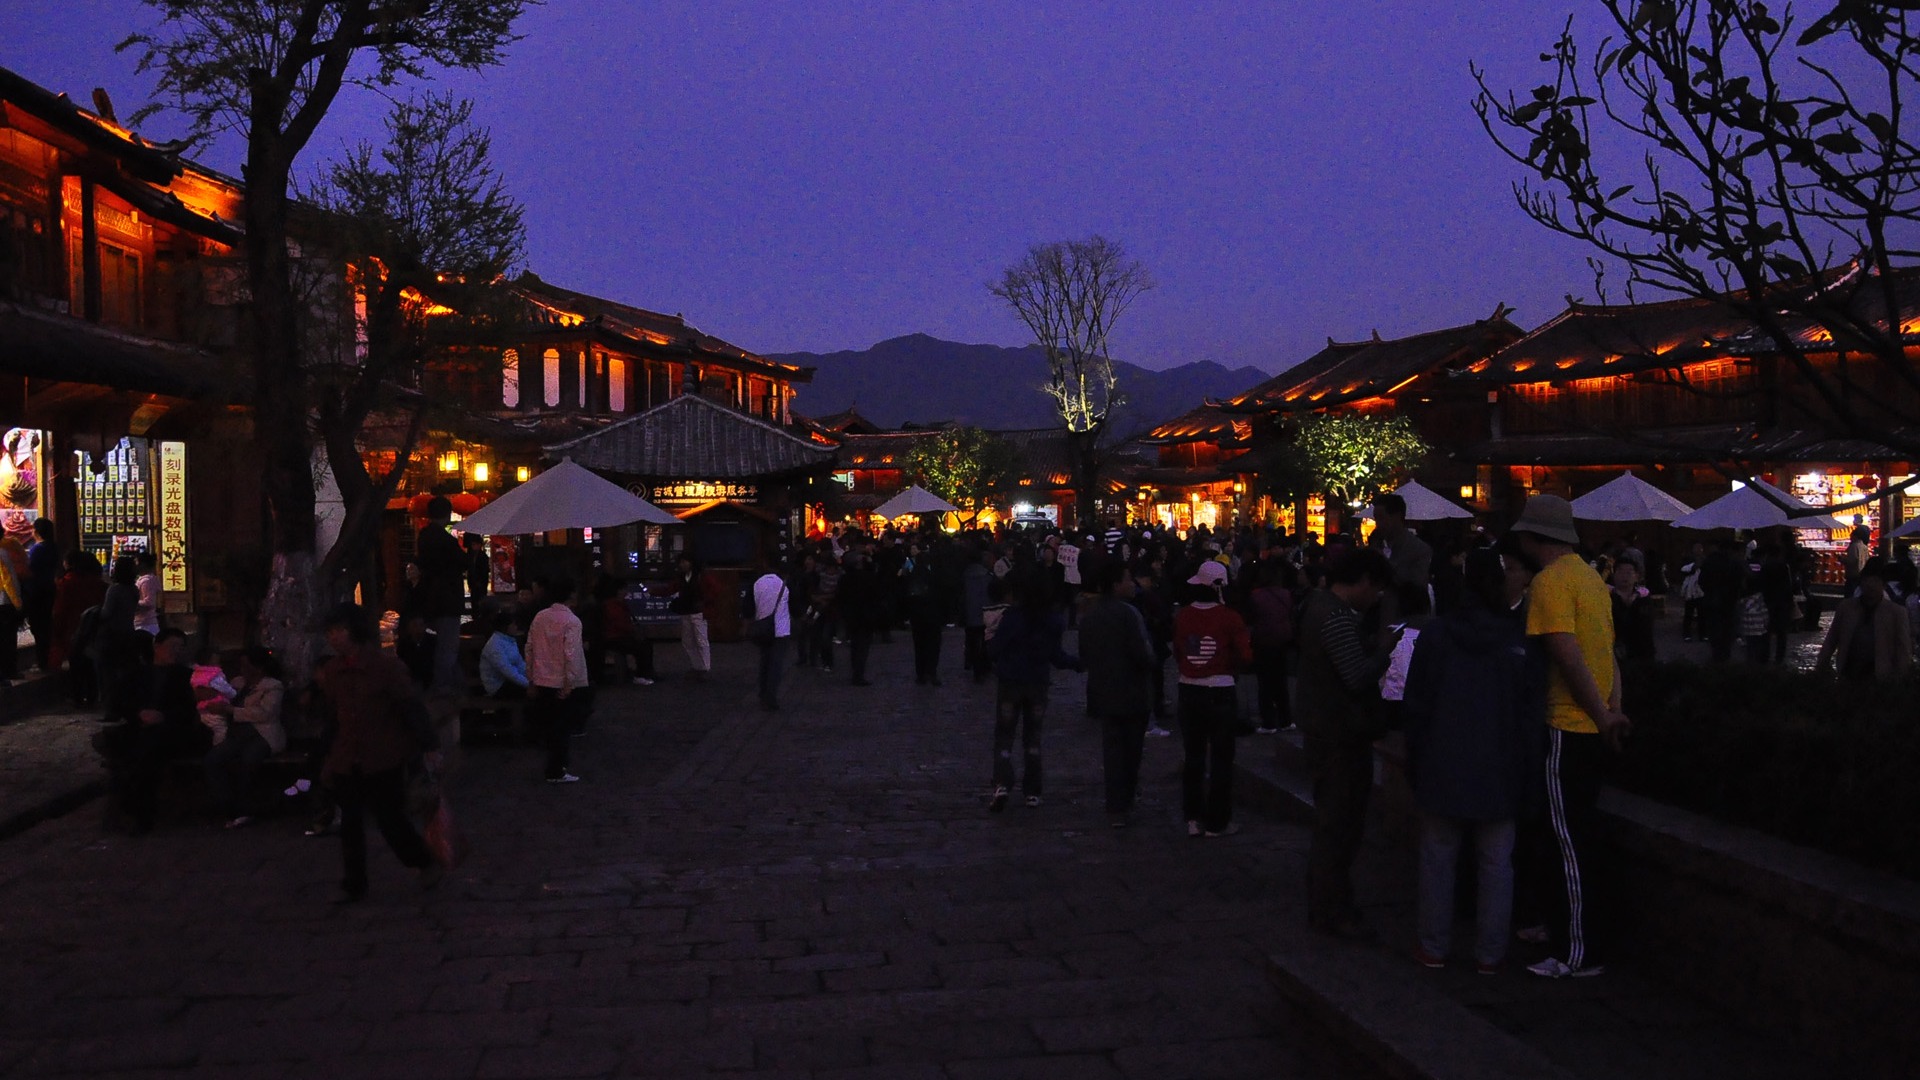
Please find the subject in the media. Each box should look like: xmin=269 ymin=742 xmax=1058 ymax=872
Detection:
xmin=309 ymin=96 xmax=526 ymax=598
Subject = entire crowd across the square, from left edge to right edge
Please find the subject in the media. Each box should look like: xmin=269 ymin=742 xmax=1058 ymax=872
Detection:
xmin=22 ymin=478 xmax=1920 ymax=926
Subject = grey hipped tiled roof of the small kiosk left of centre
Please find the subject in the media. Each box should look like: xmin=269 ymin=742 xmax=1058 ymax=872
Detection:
xmin=547 ymin=384 xmax=833 ymax=472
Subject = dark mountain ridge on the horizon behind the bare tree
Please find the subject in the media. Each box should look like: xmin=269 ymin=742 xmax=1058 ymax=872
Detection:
xmin=774 ymin=334 xmax=1267 ymax=434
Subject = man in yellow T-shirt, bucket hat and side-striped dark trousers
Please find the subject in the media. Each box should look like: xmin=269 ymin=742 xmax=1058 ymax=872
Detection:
xmin=1513 ymin=496 xmax=1632 ymax=978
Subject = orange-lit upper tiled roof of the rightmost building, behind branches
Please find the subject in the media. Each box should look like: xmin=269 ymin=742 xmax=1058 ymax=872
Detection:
xmin=1461 ymin=269 xmax=1920 ymax=384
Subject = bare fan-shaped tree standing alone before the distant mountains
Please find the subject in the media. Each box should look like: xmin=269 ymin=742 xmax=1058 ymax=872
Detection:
xmin=987 ymin=236 xmax=1154 ymax=528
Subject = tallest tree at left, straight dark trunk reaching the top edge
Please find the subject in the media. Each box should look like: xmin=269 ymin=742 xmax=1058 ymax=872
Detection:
xmin=121 ymin=0 xmax=524 ymax=667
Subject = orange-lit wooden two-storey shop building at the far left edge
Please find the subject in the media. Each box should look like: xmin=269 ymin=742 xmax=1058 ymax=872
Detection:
xmin=0 ymin=69 xmax=265 ymax=642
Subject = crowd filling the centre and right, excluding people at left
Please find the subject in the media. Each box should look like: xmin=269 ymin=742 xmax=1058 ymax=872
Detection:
xmin=702 ymin=488 xmax=1920 ymax=978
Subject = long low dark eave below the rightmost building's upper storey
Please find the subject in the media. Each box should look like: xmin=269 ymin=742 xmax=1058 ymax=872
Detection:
xmin=1461 ymin=425 xmax=1920 ymax=465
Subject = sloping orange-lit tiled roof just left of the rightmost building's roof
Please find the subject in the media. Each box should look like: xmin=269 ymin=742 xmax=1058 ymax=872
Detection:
xmin=1223 ymin=307 xmax=1524 ymax=413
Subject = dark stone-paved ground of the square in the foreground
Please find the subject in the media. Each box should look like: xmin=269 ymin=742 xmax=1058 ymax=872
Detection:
xmin=0 ymin=632 xmax=1348 ymax=1080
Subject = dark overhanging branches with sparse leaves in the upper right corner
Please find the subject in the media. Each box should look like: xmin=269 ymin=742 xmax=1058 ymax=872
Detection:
xmin=1473 ymin=0 xmax=1920 ymax=499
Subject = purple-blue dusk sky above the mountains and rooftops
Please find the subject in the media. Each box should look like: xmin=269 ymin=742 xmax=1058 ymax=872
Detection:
xmin=0 ymin=0 xmax=1651 ymax=371
